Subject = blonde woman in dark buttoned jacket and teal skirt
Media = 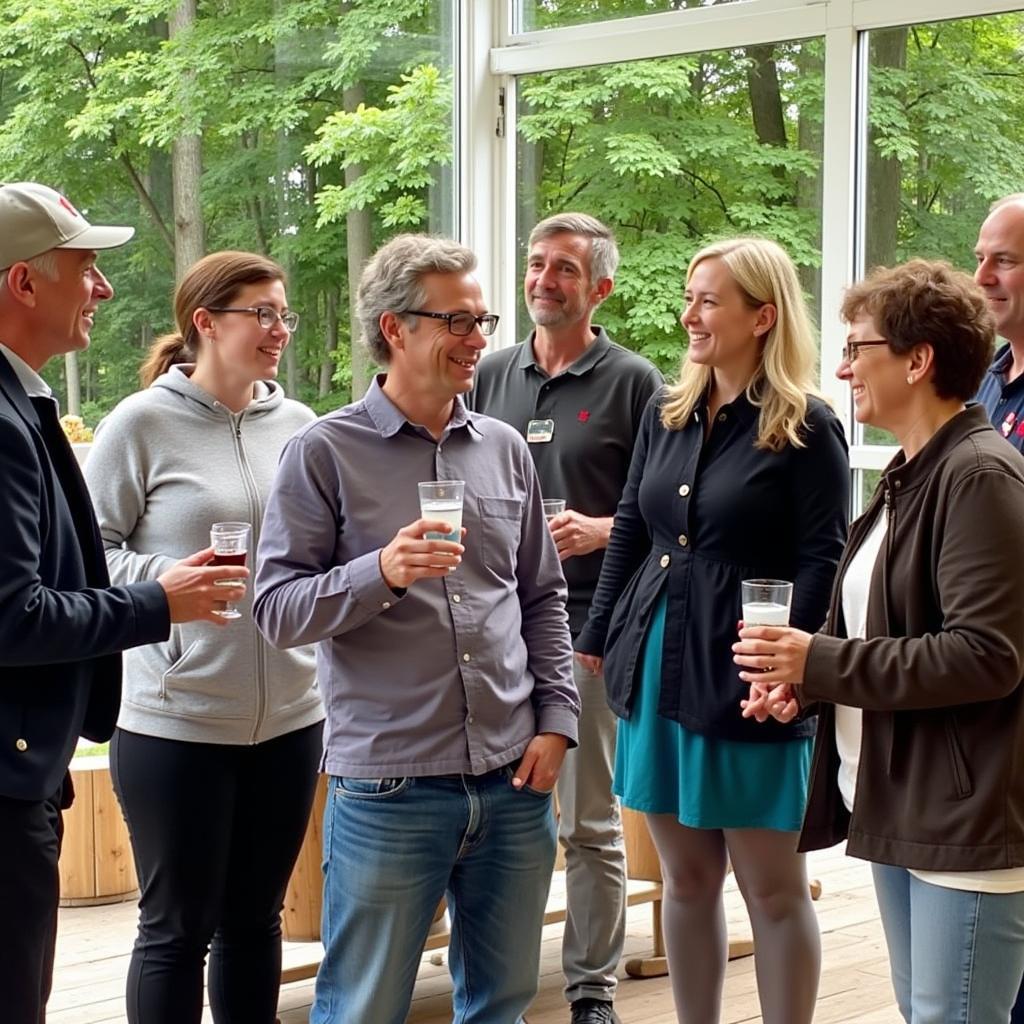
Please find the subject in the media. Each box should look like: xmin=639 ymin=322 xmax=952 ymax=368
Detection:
xmin=577 ymin=239 xmax=849 ymax=1024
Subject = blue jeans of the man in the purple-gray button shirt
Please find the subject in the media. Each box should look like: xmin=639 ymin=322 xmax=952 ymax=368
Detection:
xmin=309 ymin=768 xmax=555 ymax=1024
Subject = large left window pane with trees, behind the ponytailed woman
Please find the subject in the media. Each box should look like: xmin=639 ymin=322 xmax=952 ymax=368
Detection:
xmin=0 ymin=0 xmax=457 ymax=426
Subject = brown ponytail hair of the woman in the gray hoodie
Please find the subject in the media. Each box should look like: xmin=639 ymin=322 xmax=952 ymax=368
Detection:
xmin=138 ymin=249 xmax=287 ymax=387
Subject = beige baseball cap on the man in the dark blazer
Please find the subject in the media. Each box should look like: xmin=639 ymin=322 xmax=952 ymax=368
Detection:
xmin=0 ymin=181 xmax=135 ymax=269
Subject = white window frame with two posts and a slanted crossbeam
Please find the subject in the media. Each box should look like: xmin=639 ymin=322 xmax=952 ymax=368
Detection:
xmin=458 ymin=0 xmax=1024 ymax=505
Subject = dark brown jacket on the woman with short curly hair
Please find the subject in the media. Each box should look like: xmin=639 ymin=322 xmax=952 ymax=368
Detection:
xmin=800 ymin=406 xmax=1024 ymax=871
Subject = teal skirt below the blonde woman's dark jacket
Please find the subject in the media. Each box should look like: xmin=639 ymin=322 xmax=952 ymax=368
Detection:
xmin=614 ymin=593 xmax=814 ymax=831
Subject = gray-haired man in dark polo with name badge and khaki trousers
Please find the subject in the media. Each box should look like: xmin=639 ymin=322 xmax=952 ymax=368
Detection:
xmin=469 ymin=213 xmax=663 ymax=1024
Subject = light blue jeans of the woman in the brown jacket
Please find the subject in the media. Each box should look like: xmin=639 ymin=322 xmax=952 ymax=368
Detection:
xmin=871 ymin=864 xmax=1024 ymax=1024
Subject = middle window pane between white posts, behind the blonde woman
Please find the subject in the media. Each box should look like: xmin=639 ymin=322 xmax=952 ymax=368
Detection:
xmin=517 ymin=39 xmax=823 ymax=375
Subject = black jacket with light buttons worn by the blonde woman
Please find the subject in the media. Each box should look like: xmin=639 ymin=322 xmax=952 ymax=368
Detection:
xmin=575 ymin=394 xmax=850 ymax=742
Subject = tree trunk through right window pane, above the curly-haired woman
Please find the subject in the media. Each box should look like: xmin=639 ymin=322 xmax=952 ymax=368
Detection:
xmin=864 ymin=26 xmax=907 ymax=271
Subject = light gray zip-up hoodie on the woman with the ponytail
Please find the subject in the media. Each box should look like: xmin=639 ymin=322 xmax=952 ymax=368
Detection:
xmin=85 ymin=365 xmax=324 ymax=743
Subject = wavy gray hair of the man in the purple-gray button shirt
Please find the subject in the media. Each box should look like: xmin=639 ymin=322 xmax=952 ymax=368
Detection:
xmin=355 ymin=234 xmax=476 ymax=365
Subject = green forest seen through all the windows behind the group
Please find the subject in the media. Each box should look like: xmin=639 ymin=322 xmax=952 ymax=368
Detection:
xmin=0 ymin=0 xmax=1024 ymax=425
